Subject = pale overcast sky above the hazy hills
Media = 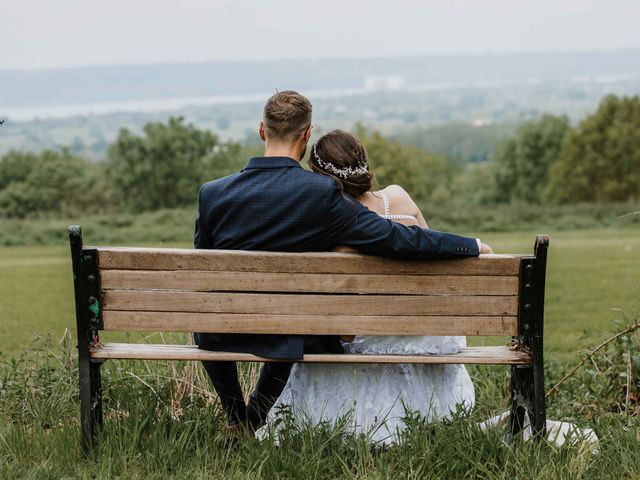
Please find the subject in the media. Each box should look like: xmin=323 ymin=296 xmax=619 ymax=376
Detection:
xmin=0 ymin=0 xmax=640 ymax=69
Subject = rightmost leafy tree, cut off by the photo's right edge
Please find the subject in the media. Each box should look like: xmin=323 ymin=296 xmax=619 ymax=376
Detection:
xmin=544 ymin=95 xmax=640 ymax=203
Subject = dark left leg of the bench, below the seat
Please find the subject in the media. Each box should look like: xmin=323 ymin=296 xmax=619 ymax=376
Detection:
xmin=78 ymin=358 xmax=102 ymax=455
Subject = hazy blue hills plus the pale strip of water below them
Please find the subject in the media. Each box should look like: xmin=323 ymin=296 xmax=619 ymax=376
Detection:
xmin=0 ymin=48 xmax=640 ymax=122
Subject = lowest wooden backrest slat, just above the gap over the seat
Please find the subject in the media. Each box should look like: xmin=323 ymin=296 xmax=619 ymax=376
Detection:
xmin=103 ymin=311 xmax=518 ymax=336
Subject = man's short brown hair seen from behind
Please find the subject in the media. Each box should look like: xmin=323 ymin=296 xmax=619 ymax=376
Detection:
xmin=262 ymin=90 xmax=311 ymax=142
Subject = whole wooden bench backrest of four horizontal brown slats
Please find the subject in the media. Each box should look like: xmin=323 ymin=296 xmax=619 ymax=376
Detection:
xmin=67 ymin=237 xmax=546 ymax=336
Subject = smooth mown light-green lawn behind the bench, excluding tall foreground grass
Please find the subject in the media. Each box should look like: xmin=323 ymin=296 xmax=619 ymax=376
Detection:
xmin=0 ymin=228 xmax=640 ymax=363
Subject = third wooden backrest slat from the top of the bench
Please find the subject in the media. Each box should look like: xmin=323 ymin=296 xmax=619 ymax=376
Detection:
xmin=103 ymin=290 xmax=518 ymax=316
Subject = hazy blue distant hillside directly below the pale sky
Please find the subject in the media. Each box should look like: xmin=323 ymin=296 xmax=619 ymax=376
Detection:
xmin=0 ymin=49 xmax=640 ymax=108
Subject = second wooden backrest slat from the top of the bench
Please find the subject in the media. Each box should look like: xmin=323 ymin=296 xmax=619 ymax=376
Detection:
xmin=100 ymin=270 xmax=518 ymax=295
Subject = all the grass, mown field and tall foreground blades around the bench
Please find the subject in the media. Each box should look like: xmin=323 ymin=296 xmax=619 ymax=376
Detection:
xmin=0 ymin=228 xmax=640 ymax=480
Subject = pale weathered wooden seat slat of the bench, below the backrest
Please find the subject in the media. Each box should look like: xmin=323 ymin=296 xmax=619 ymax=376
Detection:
xmin=91 ymin=343 xmax=532 ymax=365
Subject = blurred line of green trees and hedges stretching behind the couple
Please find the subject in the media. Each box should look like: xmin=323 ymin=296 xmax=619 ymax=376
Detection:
xmin=0 ymin=96 xmax=640 ymax=218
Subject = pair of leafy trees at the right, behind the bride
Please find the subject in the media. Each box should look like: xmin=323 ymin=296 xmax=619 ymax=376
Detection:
xmin=489 ymin=95 xmax=640 ymax=204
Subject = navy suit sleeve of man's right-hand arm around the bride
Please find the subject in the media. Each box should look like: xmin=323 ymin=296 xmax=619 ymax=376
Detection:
xmin=330 ymin=186 xmax=480 ymax=259
